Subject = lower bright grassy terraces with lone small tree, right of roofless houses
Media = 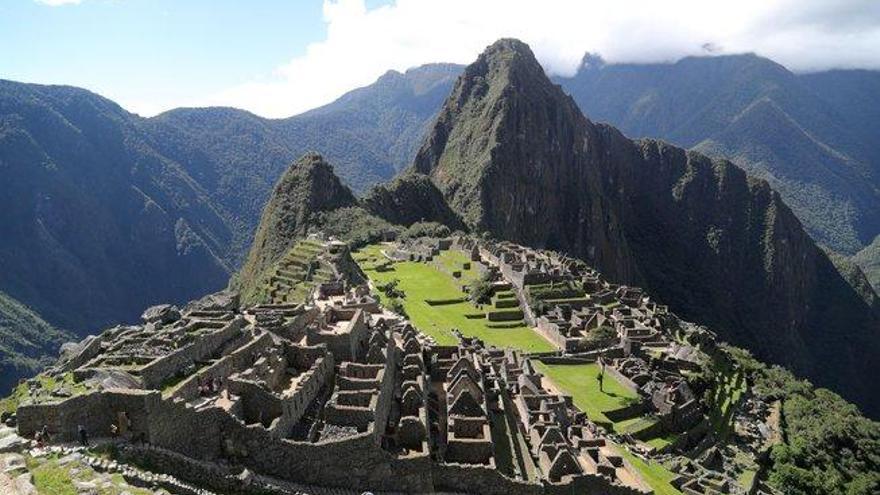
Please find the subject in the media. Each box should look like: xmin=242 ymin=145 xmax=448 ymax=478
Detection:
xmin=536 ymin=362 xmax=681 ymax=495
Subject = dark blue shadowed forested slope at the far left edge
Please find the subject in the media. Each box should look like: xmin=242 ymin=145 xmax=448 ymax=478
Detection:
xmin=0 ymin=82 xmax=230 ymax=331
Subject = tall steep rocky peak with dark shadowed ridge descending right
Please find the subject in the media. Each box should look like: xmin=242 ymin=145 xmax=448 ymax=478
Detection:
xmin=414 ymin=40 xmax=880 ymax=414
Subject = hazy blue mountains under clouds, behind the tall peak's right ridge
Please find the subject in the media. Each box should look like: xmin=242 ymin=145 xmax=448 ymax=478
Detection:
xmin=557 ymin=55 xmax=880 ymax=254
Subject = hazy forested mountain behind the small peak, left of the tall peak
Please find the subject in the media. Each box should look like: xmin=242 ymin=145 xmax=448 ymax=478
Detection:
xmin=142 ymin=64 xmax=461 ymax=266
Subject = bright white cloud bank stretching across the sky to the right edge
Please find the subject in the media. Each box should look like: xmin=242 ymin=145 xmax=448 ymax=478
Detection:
xmin=203 ymin=0 xmax=880 ymax=117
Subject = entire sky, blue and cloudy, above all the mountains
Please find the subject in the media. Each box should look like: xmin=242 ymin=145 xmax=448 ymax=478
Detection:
xmin=0 ymin=0 xmax=880 ymax=117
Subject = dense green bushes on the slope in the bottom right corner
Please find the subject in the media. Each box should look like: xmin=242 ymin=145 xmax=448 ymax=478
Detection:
xmin=729 ymin=348 xmax=880 ymax=495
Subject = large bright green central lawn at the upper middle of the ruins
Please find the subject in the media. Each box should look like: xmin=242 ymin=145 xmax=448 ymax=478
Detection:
xmin=354 ymin=246 xmax=554 ymax=352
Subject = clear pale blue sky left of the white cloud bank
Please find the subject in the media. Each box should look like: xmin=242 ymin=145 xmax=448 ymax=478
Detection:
xmin=0 ymin=0 xmax=382 ymax=113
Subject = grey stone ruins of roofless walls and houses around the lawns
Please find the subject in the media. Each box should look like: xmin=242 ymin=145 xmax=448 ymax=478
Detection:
xmin=8 ymin=237 xmax=764 ymax=494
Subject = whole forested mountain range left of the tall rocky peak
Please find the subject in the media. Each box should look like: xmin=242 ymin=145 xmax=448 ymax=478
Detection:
xmin=0 ymin=64 xmax=458 ymax=344
